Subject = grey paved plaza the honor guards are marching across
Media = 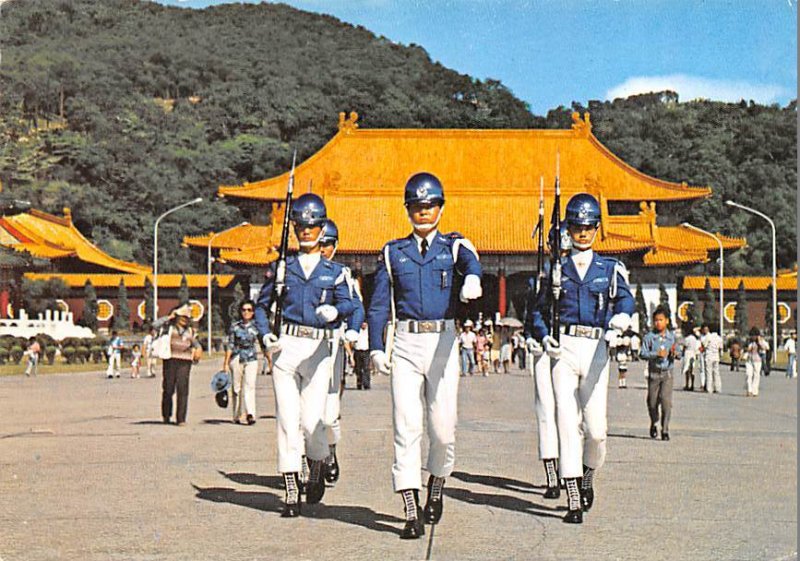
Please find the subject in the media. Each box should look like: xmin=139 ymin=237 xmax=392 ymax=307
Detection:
xmin=0 ymin=361 xmax=797 ymax=561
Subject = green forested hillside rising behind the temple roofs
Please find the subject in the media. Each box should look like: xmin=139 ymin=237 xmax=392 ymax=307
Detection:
xmin=0 ymin=0 xmax=796 ymax=271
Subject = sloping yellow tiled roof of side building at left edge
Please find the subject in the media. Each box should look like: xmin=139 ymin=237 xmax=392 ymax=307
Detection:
xmin=0 ymin=208 xmax=150 ymax=274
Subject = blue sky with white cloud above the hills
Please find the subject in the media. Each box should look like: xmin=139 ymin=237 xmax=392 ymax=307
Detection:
xmin=155 ymin=0 xmax=797 ymax=114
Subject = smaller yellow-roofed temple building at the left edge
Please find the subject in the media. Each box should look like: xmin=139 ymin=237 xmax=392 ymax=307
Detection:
xmin=0 ymin=208 xmax=235 ymax=328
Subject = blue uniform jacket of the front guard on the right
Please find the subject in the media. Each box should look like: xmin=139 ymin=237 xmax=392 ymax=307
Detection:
xmin=525 ymin=253 xmax=636 ymax=341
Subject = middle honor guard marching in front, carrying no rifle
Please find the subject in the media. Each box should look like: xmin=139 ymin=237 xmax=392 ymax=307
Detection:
xmin=367 ymin=173 xmax=482 ymax=539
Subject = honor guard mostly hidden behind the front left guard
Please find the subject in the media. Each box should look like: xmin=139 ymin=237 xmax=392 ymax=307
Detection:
xmin=319 ymin=219 xmax=364 ymax=484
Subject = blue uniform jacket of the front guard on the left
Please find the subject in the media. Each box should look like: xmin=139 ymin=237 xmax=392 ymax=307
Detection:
xmin=255 ymin=256 xmax=356 ymax=337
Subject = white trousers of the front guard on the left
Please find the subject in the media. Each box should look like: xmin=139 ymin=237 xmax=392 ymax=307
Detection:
xmin=272 ymin=334 xmax=333 ymax=473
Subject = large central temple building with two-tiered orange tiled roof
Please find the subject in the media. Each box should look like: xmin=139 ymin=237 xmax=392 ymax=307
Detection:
xmin=184 ymin=113 xmax=745 ymax=315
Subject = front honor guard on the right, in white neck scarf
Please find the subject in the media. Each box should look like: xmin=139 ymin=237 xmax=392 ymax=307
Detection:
xmin=529 ymin=193 xmax=635 ymax=524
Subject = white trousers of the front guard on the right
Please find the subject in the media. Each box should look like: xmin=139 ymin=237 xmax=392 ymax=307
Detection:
xmin=553 ymin=335 xmax=608 ymax=478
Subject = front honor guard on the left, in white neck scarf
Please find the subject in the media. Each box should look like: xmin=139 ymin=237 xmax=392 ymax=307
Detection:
xmin=256 ymin=193 xmax=355 ymax=517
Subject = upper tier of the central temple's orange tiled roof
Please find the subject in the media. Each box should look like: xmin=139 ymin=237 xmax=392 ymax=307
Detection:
xmin=218 ymin=113 xmax=711 ymax=201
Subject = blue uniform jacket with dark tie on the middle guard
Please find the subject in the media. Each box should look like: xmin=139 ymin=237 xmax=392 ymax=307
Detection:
xmin=367 ymin=232 xmax=481 ymax=351
